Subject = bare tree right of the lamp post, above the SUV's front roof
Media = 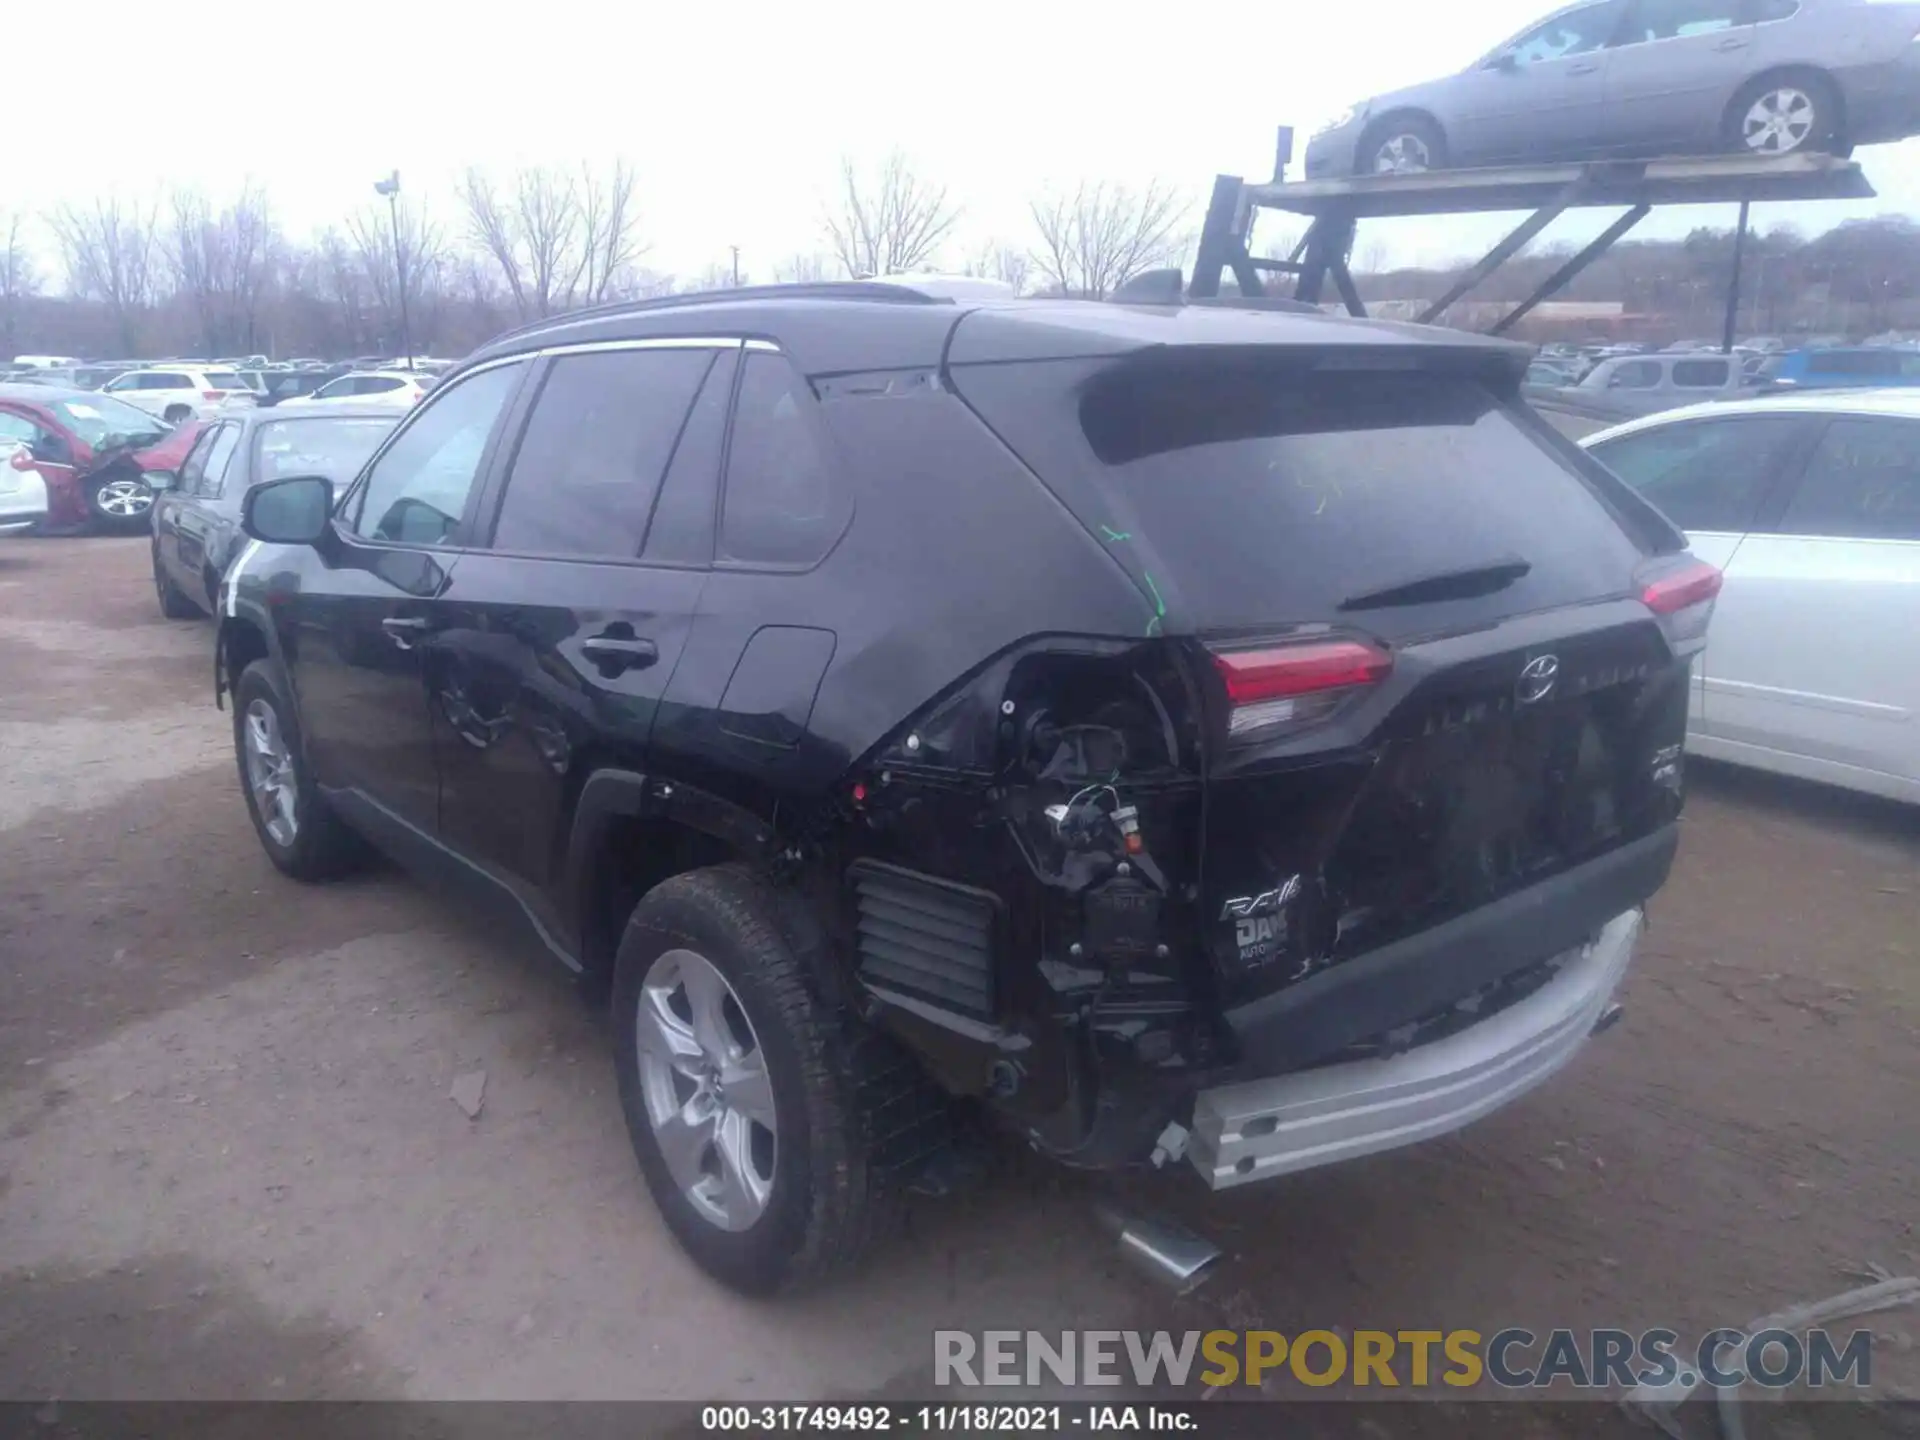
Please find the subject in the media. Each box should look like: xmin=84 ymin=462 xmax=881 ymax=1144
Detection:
xmin=459 ymin=159 xmax=643 ymax=321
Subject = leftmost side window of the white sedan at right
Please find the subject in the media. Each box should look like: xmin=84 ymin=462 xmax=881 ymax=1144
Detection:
xmin=1588 ymin=415 xmax=1801 ymax=536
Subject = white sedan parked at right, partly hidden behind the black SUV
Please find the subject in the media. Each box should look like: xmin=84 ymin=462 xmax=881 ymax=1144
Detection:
xmin=1580 ymin=390 xmax=1920 ymax=803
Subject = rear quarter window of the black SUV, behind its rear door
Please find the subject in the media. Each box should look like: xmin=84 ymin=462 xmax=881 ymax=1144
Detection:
xmin=720 ymin=349 xmax=852 ymax=566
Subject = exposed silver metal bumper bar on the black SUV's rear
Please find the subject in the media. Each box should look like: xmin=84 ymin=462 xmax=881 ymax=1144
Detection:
xmin=1187 ymin=908 xmax=1642 ymax=1190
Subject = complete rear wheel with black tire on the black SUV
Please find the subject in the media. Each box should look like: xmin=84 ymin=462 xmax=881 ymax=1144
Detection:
xmin=612 ymin=866 xmax=931 ymax=1296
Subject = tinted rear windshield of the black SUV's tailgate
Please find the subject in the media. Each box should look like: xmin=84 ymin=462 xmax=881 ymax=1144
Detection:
xmin=960 ymin=363 xmax=1640 ymax=634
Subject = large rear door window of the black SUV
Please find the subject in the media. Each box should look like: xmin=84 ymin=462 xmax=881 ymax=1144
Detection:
xmin=493 ymin=349 xmax=712 ymax=559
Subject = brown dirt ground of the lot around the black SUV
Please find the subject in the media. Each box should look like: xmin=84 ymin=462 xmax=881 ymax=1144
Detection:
xmin=0 ymin=540 xmax=1920 ymax=1400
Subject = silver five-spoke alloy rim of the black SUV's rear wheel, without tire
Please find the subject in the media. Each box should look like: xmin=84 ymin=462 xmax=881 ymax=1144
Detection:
xmin=636 ymin=950 xmax=778 ymax=1231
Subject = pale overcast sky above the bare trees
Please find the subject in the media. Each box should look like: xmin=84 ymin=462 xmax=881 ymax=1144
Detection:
xmin=0 ymin=0 xmax=1920 ymax=278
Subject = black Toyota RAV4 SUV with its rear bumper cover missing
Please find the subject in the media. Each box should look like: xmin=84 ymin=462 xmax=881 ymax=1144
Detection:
xmin=217 ymin=282 xmax=1718 ymax=1290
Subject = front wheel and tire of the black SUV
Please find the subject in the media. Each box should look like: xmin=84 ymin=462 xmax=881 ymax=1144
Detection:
xmin=234 ymin=660 xmax=367 ymax=881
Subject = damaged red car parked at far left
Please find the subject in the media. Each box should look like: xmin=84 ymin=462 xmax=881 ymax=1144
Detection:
xmin=0 ymin=386 xmax=202 ymax=534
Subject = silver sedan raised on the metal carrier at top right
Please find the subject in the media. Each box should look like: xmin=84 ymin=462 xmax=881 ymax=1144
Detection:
xmin=1308 ymin=0 xmax=1920 ymax=180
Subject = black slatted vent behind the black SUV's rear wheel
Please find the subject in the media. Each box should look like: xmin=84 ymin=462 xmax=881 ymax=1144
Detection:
xmin=849 ymin=860 xmax=996 ymax=1020
